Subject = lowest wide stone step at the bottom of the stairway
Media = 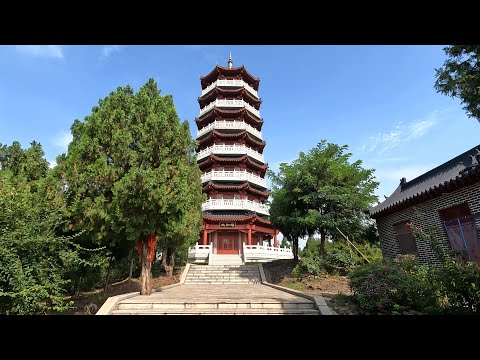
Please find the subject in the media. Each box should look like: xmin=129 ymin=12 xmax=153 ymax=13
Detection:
xmin=112 ymin=309 xmax=320 ymax=315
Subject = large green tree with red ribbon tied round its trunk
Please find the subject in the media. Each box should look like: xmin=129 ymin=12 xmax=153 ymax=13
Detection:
xmin=64 ymin=79 xmax=202 ymax=295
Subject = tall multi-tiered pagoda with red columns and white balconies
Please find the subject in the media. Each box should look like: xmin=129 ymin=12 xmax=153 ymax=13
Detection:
xmin=195 ymin=56 xmax=278 ymax=254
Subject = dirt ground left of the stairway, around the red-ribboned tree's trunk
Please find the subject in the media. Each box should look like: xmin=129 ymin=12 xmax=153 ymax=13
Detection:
xmin=53 ymin=267 xmax=183 ymax=315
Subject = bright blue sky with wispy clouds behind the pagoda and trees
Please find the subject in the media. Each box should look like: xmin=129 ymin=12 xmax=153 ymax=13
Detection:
xmin=0 ymin=45 xmax=480 ymax=199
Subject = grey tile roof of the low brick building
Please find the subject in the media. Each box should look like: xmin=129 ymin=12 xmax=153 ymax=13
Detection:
xmin=369 ymin=144 xmax=480 ymax=217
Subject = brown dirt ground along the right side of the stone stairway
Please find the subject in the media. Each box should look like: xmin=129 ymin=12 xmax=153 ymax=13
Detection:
xmin=263 ymin=259 xmax=361 ymax=315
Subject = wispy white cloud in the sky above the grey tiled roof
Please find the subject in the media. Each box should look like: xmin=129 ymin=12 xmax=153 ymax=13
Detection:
xmin=362 ymin=110 xmax=439 ymax=154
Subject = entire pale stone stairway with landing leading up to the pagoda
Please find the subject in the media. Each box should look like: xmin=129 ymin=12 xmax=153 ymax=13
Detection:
xmin=105 ymin=264 xmax=320 ymax=315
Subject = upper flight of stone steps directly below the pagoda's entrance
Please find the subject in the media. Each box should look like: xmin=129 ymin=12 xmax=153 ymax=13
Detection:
xmin=185 ymin=265 xmax=261 ymax=285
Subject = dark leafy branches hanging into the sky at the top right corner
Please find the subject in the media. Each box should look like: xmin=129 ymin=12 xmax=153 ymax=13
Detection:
xmin=435 ymin=45 xmax=480 ymax=122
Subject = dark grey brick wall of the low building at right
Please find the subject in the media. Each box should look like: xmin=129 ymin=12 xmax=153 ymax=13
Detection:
xmin=376 ymin=182 xmax=480 ymax=263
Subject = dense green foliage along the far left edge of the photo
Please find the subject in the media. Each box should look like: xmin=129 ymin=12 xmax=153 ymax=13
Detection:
xmin=0 ymin=153 xmax=103 ymax=314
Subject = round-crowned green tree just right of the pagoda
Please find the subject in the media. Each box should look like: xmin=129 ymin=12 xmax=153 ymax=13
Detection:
xmin=271 ymin=140 xmax=378 ymax=256
